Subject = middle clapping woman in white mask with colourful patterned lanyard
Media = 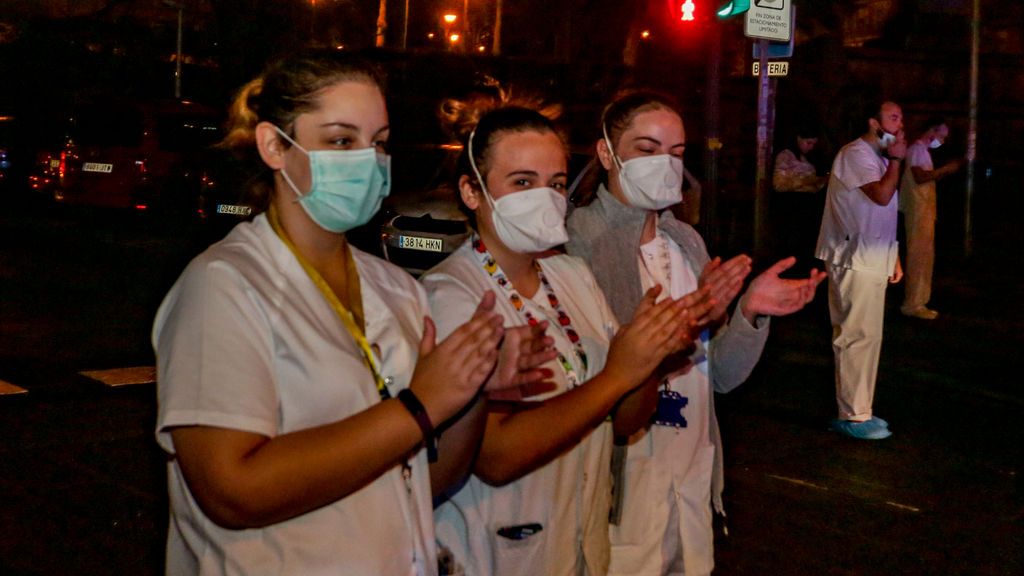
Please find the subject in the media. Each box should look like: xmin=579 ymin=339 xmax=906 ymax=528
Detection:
xmin=422 ymin=102 xmax=712 ymax=575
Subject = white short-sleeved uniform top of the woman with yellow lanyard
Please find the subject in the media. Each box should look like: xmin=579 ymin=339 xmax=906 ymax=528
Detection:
xmin=153 ymin=215 xmax=437 ymax=576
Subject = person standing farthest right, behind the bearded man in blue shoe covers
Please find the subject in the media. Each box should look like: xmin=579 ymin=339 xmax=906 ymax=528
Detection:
xmin=899 ymin=116 xmax=962 ymax=320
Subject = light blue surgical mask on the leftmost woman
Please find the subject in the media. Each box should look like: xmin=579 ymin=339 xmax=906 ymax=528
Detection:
xmin=274 ymin=126 xmax=391 ymax=234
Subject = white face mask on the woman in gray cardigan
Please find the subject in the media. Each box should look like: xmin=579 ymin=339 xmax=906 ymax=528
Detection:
xmin=601 ymin=126 xmax=683 ymax=210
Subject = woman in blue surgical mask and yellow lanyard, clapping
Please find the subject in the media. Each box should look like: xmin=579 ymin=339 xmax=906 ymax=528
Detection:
xmin=153 ymin=51 xmax=548 ymax=576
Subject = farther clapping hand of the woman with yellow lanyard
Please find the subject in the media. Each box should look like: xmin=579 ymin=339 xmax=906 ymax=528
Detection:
xmin=483 ymin=321 xmax=558 ymax=392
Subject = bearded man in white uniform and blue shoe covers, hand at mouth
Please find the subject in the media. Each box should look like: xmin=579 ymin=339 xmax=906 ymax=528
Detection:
xmin=815 ymin=101 xmax=906 ymax=440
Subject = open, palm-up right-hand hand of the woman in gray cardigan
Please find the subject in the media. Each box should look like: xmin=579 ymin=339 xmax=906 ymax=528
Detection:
xmin=741 ymin=256 xmax=828 ymax=323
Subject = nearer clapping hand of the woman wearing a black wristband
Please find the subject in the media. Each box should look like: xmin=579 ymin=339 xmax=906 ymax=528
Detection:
xmin=409 ymin=290 xmax=505 ymax=426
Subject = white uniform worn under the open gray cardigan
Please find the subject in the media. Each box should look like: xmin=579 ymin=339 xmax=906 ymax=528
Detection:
xmin=608 ymin=231 xmax=715 ymax=576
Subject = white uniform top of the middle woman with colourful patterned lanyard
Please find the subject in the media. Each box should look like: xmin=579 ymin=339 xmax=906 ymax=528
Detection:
xmin=422 ymin=241 xmax=617 ymax=576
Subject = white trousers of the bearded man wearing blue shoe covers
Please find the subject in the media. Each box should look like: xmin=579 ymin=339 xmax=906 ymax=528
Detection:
xmin=825 ymin=264 xmax=889 ymax=420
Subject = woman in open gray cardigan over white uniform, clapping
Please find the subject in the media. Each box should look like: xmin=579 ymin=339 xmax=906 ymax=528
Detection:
xmin=566 ymin=91 xmax=824 ymax=576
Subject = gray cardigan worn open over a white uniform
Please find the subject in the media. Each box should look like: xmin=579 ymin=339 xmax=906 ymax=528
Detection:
xmin=565 ymin=184 xmax=769 ymax=512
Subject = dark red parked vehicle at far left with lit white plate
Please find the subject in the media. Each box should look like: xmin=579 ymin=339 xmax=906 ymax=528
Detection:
xmin=29 ymin=96 xmax=221 ymax=214
